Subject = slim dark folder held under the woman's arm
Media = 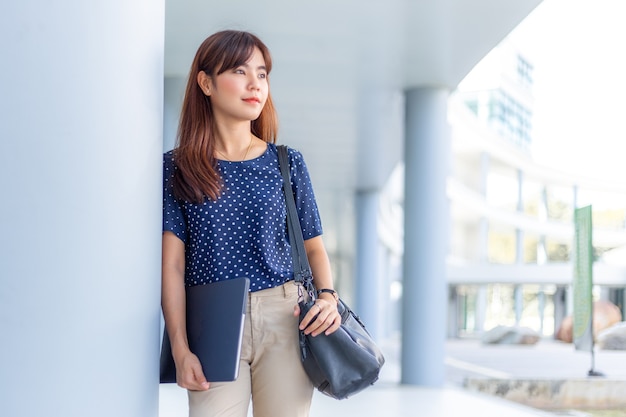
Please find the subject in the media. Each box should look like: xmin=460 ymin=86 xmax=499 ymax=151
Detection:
xmin=160 ymin=278 xmax=250 ymax=383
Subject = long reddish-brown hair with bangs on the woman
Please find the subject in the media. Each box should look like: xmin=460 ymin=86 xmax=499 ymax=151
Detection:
xmin=173 ymin=30 xmax=278 ymax=203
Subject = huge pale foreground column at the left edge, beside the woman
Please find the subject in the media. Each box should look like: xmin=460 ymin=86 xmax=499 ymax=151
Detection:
xmin=0 ymin=0 xmax=164 ymax=417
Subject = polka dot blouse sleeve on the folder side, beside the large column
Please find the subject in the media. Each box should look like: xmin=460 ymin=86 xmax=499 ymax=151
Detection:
xmin=163 ymin=151 xmax=187 ymax=242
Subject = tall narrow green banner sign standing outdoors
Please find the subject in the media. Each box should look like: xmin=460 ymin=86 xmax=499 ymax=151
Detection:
xmin=573 ymin=206 xmax=593 ymax=351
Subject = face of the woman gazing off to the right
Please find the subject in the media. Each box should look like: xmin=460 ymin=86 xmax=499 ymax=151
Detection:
xmin=199 ymin=48 xmax=269 ymax=122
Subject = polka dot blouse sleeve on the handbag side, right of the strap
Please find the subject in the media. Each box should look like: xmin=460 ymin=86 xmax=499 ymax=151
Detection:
xmin=289 ymin=148 xmax=323 ymax=240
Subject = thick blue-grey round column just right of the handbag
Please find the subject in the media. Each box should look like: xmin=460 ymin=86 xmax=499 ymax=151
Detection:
xmin=401 ymin=88 xmax=450 ymax=387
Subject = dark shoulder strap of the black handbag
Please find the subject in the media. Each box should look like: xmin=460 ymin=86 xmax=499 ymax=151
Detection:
xmin=276 ymin=145 xmax=315 ymax=290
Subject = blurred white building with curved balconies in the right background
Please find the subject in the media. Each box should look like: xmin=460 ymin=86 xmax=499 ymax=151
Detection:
xmin=428 ymin=36 xmax=626 ymax=337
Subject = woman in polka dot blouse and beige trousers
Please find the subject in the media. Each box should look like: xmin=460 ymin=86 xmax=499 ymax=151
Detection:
xmin=162 ymin=31 xmax=341 ymax=417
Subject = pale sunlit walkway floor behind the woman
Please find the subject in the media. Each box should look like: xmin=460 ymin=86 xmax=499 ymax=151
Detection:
xmin=159 ymin=340 xmax=626 ymax=417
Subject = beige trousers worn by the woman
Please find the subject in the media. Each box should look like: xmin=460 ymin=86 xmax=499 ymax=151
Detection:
xmin=188 ymin=281 xmax=313 ymax=417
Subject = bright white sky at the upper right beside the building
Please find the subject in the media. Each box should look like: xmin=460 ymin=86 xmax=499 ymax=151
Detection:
xmin=510 ymin=0 xmax=626 ymax=183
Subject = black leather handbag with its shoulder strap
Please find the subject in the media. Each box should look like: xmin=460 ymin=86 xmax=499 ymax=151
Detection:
xmin=277 ymin=146 xmax=385 ymax=400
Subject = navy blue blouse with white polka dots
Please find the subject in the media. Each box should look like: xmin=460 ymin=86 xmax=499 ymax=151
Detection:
xmin=163 ymin=144 xmax=322 ymax=291
